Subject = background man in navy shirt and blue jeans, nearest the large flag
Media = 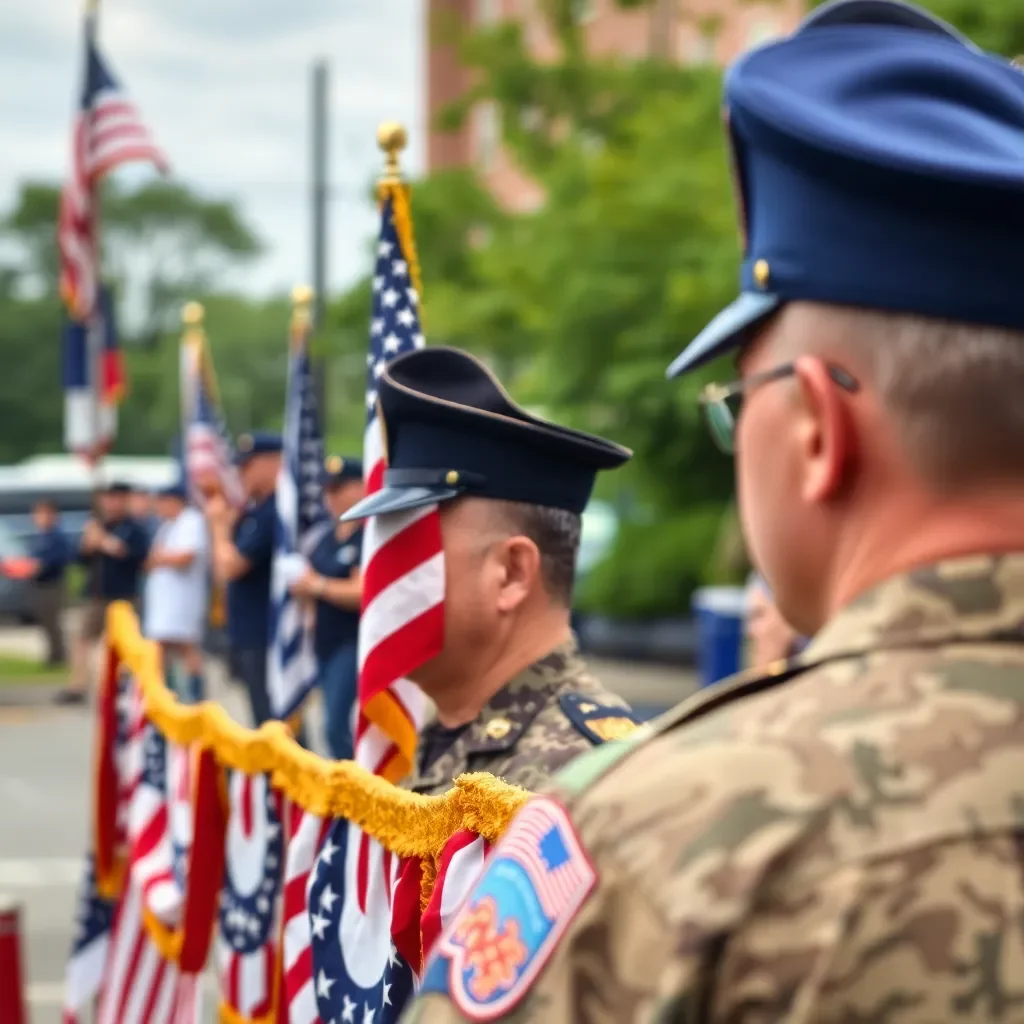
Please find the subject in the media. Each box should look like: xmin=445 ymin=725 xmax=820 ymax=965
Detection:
xmin=292 ymin=456 xmax=366 ymax=759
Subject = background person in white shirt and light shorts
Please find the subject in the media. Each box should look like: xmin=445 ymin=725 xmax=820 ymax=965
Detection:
xmin=142 ymin=484 xmax=210 ymax=702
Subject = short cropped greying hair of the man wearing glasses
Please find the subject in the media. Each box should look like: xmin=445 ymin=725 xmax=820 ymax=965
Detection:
xmin=841 ymin=309 xmax=1024 ymax=495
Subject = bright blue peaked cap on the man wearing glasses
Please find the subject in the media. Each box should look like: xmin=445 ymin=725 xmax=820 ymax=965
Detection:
xmin=669 ymin=0 xmax=1024 ymax=377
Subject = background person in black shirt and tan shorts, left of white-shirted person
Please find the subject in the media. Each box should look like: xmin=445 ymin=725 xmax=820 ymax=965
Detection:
xmin=56 ymin=483 xmax=150 ymax=703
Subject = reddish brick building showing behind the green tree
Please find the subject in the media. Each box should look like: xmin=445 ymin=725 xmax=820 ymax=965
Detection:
xmin=426 ymin=0 xmax=803 ymax=210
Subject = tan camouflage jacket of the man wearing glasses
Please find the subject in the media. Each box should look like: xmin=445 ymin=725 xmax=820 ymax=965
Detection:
xmin=408 ymin=555 xmax=1024 ymax=1024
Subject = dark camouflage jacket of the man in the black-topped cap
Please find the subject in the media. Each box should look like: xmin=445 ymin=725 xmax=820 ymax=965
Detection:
xmin=401 ymin=640 xmax=634 ymax=795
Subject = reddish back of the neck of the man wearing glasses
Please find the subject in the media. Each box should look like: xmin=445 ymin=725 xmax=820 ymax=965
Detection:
xmin=826 ymin=496 xmax=1024 ymax=617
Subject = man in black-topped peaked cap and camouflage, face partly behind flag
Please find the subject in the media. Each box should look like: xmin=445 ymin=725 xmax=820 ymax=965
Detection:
xmin=344 ymin=347 xmax=635 ymax=794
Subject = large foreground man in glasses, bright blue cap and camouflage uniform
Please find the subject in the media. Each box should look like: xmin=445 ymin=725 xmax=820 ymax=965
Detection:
xmin=406 ymin=0 xmax=1024 ymax=1024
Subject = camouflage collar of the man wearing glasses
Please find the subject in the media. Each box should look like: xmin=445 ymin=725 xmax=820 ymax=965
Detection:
xmin=795 ymin=553 xmax=1024 ymax=664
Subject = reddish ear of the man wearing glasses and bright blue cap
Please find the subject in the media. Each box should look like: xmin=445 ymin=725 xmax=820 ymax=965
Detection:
xmin=796 ymin=355 xmax=856 ymax=503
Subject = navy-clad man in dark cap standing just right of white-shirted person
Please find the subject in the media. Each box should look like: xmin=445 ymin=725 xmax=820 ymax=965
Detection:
xmin=206 ymin=433 xmax=282 ymax=726
